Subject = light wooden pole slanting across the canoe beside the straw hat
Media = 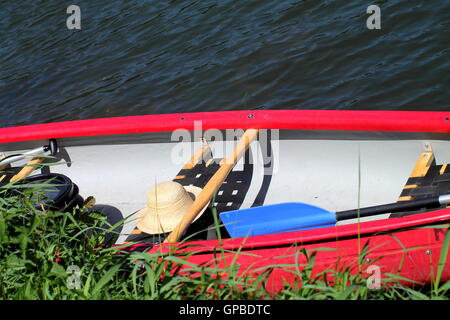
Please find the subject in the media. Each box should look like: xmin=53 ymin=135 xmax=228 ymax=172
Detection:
xmin=164 ymin=129 xmax=259 ymax=243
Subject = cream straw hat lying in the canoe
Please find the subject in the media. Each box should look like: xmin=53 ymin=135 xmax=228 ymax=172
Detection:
xmin=136 ymin=181 xmax=209 ymax=234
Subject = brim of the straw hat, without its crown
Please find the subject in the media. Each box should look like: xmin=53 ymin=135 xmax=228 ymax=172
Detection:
xmin=136 ymin=186 xmax=211 ymax=234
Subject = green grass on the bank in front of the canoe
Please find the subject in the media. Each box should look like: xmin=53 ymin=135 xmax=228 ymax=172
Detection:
xmin=0 ymin=179 xmax=450 ymax=300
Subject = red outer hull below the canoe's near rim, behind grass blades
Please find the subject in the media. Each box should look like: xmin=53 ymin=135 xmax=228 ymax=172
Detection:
xmin=184 ymin=221 xmax=450 ymax=292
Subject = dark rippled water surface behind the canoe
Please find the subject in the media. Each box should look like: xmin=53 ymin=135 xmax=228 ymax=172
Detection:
xmin=0 ymin=0 xmax=450 ymax=127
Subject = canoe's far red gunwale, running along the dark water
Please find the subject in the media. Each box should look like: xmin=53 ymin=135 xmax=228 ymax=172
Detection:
xmin=0 ymin=110 xmax=450 ymax=143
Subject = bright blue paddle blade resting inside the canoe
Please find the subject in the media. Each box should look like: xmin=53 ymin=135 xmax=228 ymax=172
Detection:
xmin=220 ymin=202 xmax=336 ymax=238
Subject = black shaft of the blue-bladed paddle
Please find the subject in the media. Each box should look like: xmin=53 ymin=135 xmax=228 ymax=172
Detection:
xmin=336 ymin=197 xmax=443 ymax=221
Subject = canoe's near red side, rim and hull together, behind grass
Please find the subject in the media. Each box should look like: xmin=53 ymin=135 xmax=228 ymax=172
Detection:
xmin=151 ymin=209 xmax=450 ymax=292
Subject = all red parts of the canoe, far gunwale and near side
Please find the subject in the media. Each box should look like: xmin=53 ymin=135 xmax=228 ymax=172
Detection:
xmin=0 ymin=110 xmax=450 ymax=291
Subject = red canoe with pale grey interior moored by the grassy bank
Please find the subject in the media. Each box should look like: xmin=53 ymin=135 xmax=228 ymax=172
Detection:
xmin=0 ymin=110 xmax=450 ymax=290
